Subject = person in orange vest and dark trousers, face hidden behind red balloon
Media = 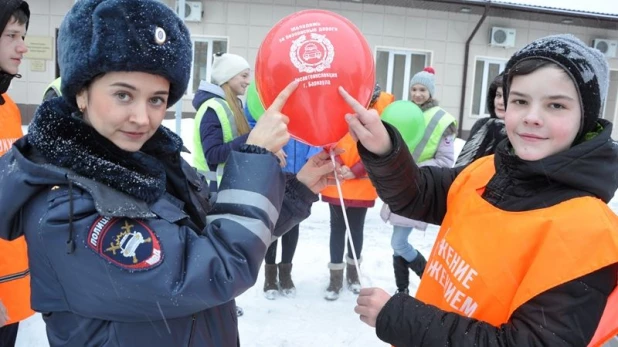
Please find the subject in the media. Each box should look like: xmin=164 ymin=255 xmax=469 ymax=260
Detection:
xmin=321 ymin=85 xmax=394 ymax=301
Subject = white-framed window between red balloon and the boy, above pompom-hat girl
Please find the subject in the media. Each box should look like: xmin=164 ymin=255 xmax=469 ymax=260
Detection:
xmin=376 ymin=48 xmax=431 ymax=100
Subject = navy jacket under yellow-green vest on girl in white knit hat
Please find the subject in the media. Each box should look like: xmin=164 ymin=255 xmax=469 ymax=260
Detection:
xmin=193 ymin=81 xmax=249 ymax=182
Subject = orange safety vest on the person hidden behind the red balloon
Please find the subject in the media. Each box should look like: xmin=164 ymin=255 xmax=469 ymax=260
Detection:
xmin=320 ymin=92 xmax=395 ymax=201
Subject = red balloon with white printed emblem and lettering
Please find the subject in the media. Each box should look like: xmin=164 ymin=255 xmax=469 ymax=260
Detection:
xmin=255 ymin=10 xmax=375 ymax=146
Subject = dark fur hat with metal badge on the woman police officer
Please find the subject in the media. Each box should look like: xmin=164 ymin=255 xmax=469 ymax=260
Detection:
xmin=58 ymin=0 xmax=192 ymax=107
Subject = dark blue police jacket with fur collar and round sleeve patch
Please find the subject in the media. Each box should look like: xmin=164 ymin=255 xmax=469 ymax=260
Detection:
xmin=0 ymin=98 xmax=317 ymax=347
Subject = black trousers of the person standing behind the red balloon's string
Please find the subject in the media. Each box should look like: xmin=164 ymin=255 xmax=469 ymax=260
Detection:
xmin=329 ymin=204 xmax=367 ymax=264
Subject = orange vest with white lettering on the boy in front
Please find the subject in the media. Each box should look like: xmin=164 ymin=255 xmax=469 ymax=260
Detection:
xmin=416 ymin=155 xmax=618 ymax=346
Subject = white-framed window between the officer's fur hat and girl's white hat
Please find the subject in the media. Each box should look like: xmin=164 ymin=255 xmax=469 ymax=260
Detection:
xmin=187 ymin=37 xmax=227 ymax=94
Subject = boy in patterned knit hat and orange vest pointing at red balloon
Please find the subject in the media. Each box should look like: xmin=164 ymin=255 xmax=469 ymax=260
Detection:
xmin=341 ymin=35 xmax=618 ymax=347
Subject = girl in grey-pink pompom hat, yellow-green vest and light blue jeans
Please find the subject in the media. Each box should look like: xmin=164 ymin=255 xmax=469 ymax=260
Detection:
xmin=380 ymin=67 xmax=457 ymax=293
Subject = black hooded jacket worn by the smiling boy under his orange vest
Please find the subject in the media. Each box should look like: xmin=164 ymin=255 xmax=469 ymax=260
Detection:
xmin=359 ymin=120 xmax=618 ymax=347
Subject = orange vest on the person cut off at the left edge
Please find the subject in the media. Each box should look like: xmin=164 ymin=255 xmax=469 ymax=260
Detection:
xmin=0 ymin=94 xmax=34 ymax=324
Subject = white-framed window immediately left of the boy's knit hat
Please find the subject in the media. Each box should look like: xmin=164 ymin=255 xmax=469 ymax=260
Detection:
xmin=472 ymin=58 xmax=506 ymax=117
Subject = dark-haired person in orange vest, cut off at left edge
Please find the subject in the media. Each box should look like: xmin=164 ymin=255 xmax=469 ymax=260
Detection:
xmin=0 ymin=0 xmax=34 ymax=347
